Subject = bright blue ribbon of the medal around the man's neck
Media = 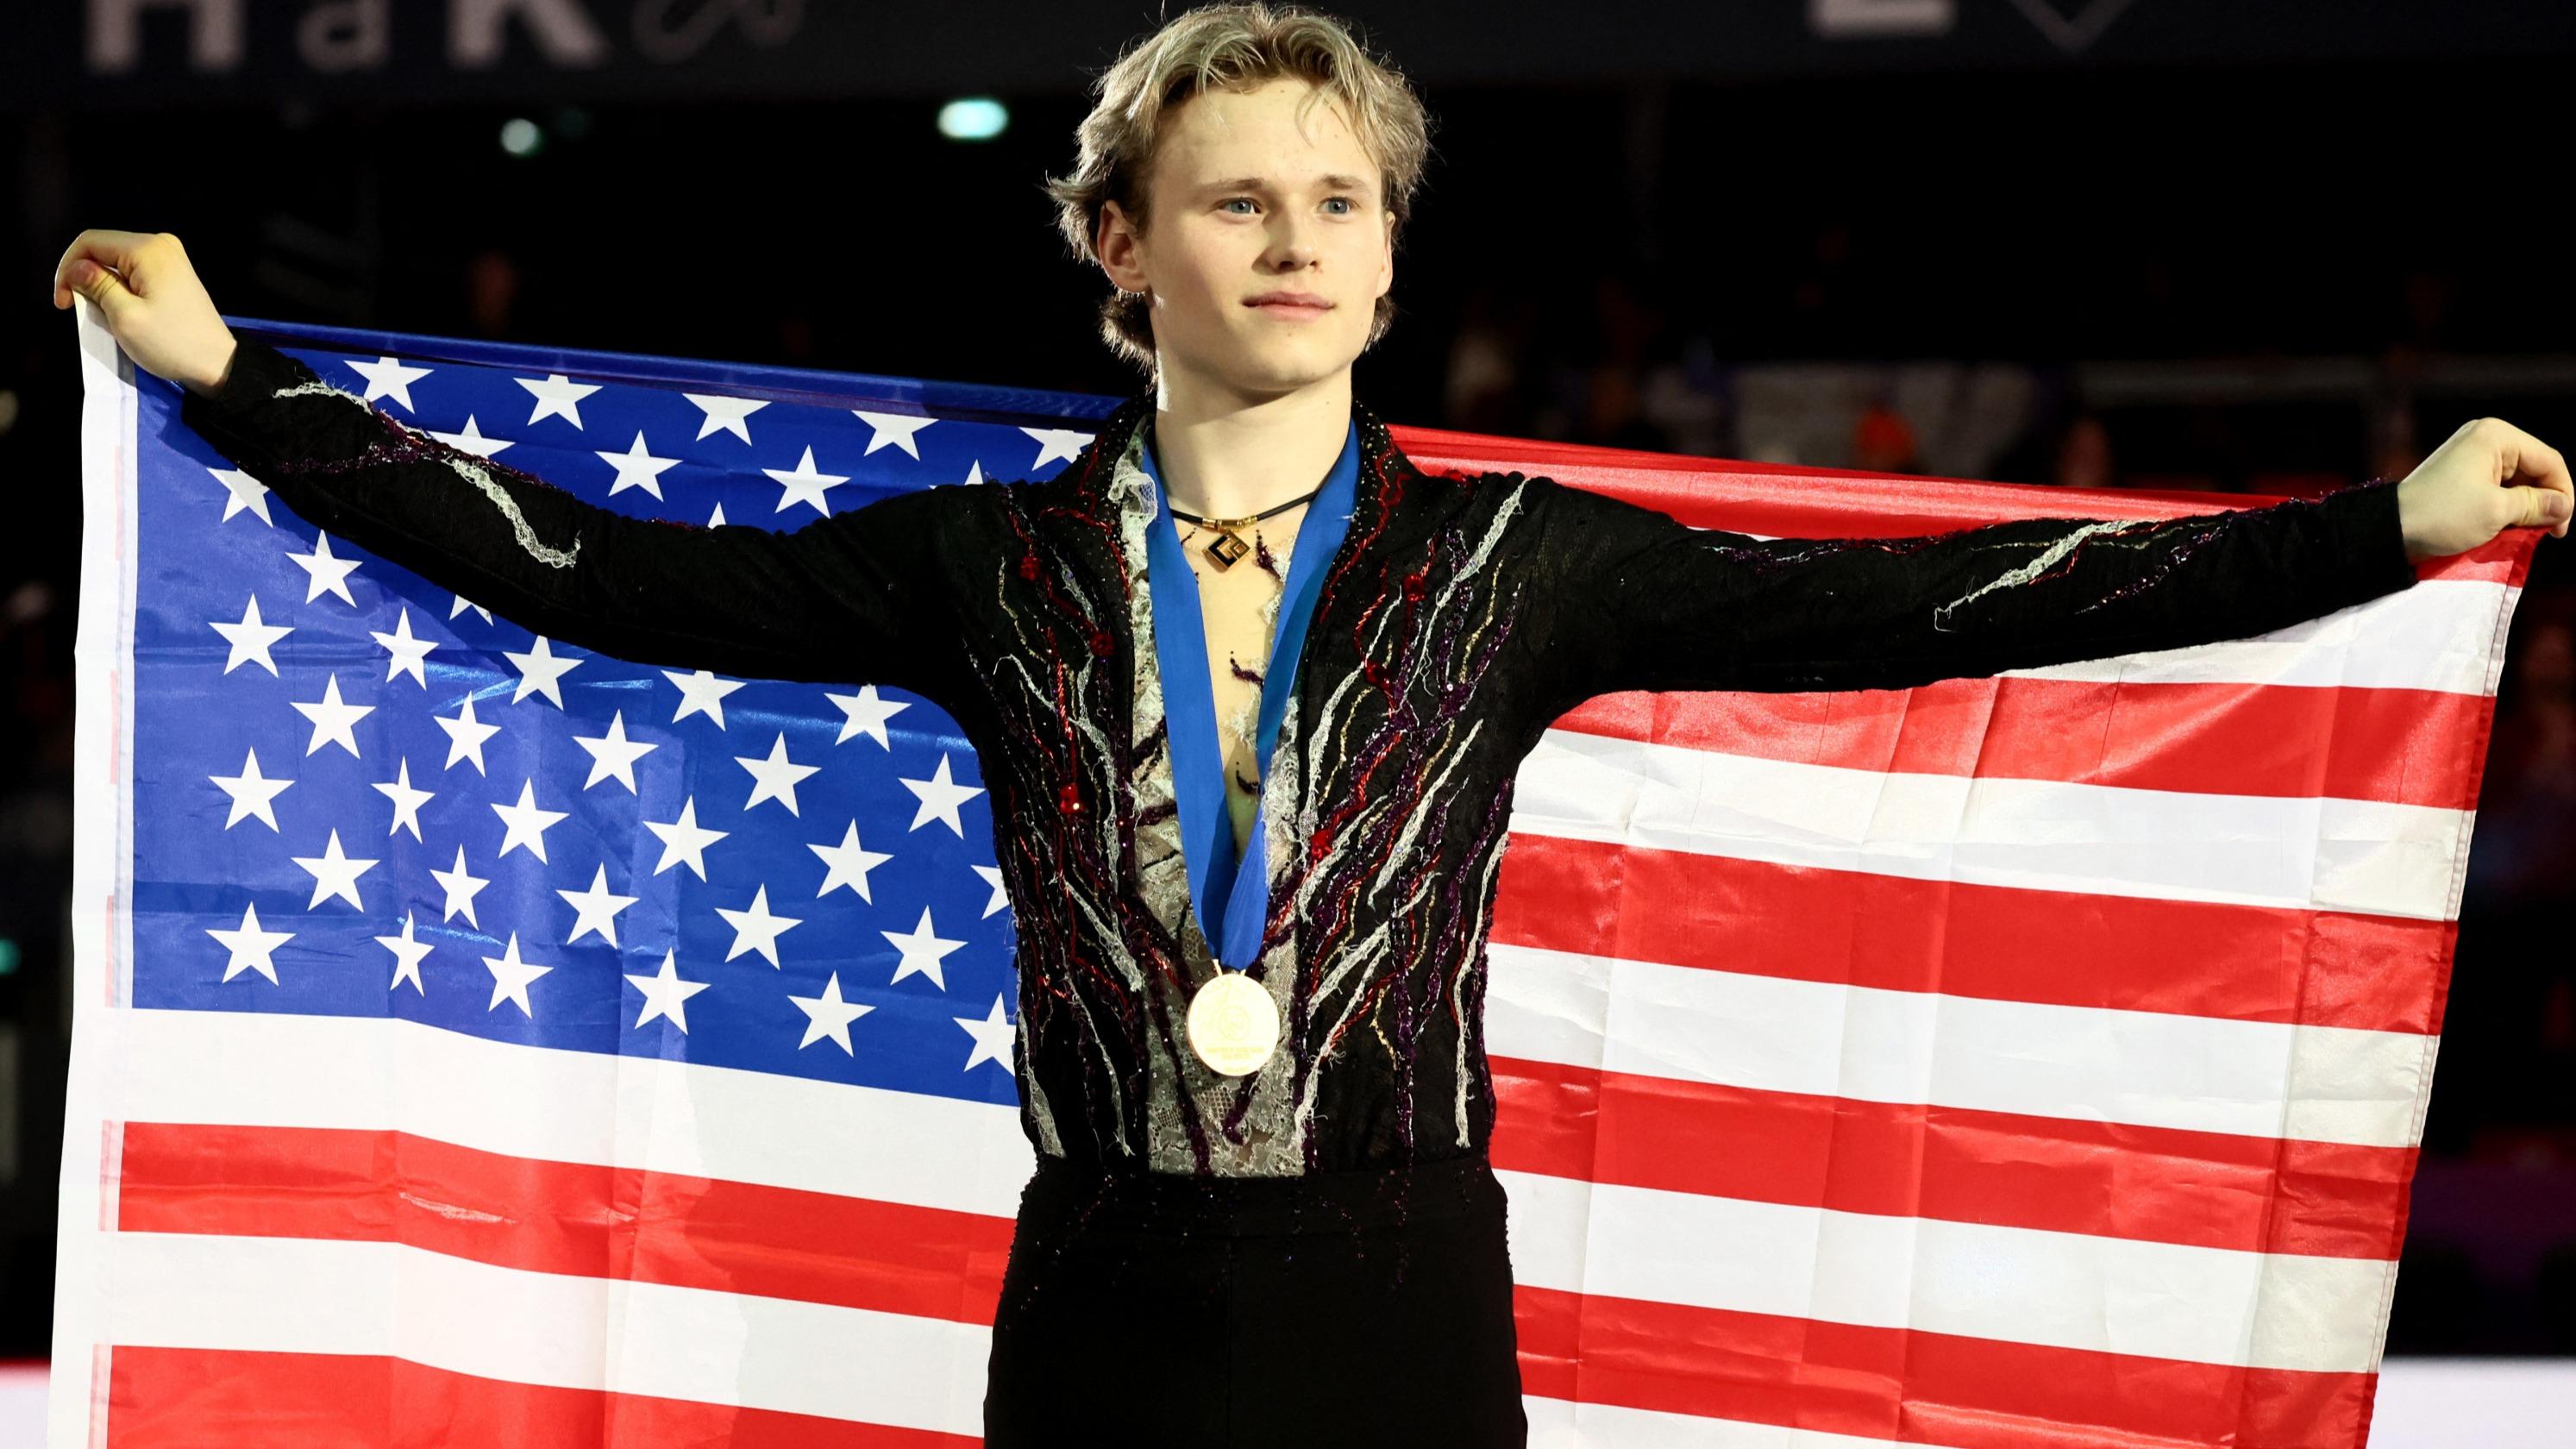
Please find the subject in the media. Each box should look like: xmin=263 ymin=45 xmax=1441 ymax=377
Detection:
xmin=1144 ymin=420 xmax=1360 ymax=969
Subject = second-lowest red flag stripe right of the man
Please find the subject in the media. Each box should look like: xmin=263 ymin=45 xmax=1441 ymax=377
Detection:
xmin=1491 ymin=1057 xmax=2416 ymax=1261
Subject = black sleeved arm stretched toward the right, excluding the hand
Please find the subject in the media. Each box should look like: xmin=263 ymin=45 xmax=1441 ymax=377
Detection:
xmin=1530 ymin=464 xmax=2416 ymax=709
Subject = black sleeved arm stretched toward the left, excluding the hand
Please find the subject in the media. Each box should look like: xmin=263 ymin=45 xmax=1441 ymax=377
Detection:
xmin=180 ymin=336 xmax=961 ymax=696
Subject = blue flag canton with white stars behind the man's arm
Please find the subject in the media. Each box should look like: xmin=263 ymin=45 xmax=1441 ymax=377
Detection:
xmin=131 ymin=328 xmax=1115 ymax=1103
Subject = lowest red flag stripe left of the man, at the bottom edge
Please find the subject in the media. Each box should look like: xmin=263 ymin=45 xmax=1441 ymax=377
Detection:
xmin=105 ymin=1343 xmax=981 ymax=1449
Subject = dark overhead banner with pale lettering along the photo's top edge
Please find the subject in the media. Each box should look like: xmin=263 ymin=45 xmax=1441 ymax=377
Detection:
xmin=20 ymin=0 xmax=2576 ymax=109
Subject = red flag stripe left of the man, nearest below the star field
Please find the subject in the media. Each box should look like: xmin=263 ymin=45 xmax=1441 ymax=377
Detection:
xmin=116 ymin=1121 xmax=1012 ymax=1323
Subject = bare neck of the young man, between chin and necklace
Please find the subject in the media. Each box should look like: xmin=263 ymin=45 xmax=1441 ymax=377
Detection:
xmin=1154 ymin=366 xmax=1350 ymax=518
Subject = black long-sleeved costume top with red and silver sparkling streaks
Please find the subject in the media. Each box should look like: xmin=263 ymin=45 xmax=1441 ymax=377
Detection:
xmin=183 ymin=336 xmax=2416 ymax=1176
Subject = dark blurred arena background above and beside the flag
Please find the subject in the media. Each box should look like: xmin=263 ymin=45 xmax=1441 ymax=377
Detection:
xmin=0 ymin=0 xmax=2576 ymax=1358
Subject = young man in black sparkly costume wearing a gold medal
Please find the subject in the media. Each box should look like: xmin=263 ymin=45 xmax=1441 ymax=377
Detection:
xmin=57 ymin=5 xmax=2568 ymax=1449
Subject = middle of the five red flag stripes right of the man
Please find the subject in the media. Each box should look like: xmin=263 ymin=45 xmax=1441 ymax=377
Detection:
xmin=1491 ymin=836 xmax=2458 ymax=1034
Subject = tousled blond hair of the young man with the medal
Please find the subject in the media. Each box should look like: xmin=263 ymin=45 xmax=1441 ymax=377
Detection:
xmin=1046 ymin=5 xmax=1430 ymax=373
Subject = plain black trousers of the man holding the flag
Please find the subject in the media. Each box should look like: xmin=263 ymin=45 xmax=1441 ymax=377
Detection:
xmin=984 ymin=1155 xmax=1527 ymax=1449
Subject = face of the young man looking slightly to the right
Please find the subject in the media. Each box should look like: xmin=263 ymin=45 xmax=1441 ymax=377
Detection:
xmin=1097 ymin=80 xmax=1396 ymax=402
